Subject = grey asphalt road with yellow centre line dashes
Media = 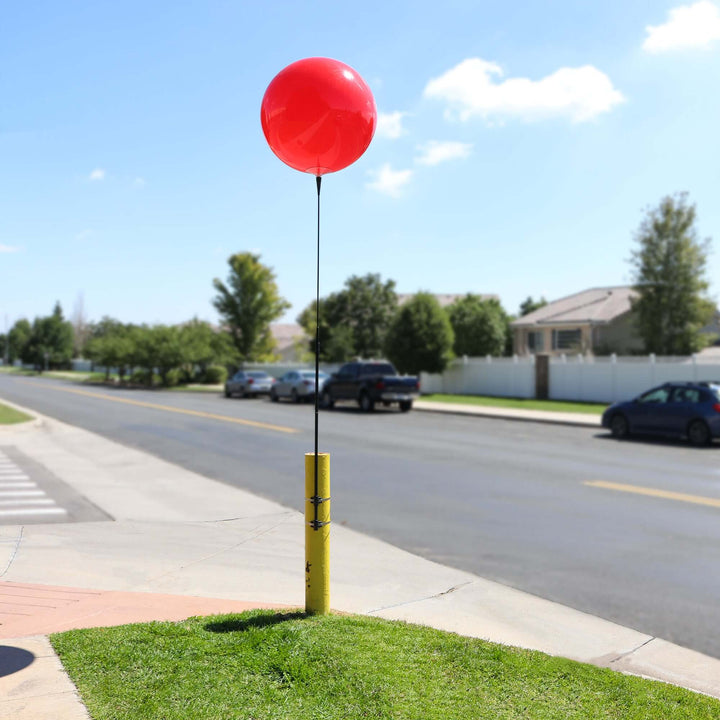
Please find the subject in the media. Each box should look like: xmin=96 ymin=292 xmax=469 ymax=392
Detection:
xmin=0 ymin=374 xmax=720 ymax=658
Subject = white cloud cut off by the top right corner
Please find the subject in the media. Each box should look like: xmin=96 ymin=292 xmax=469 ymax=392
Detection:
xmin=643 ymin=0 xmax=720 ymax=53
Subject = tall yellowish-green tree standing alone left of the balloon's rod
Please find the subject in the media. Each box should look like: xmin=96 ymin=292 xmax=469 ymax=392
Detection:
xmin=213 ymin=253 xmax=290 ymax=362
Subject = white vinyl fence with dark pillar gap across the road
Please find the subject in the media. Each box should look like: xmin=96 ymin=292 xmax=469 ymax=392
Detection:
xmin=421 ymin=355 xmax=720 ymax=403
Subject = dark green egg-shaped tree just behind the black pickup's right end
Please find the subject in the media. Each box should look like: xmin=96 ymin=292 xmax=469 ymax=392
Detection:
xmin=385 ymin=292 xmax=454 ymax=375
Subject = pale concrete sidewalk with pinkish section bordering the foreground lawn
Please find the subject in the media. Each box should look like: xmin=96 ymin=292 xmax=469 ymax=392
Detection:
xmin=0 ymin=402 xmax=720 ymax=720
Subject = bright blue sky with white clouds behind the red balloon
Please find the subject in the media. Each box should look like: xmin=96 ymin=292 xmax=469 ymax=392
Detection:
xmin=0 ymin=0 xmax=720 ymax=330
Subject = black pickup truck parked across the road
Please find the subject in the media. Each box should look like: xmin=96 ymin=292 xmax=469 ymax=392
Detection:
xmin=320 ymin=361 xmax=420 ymax=412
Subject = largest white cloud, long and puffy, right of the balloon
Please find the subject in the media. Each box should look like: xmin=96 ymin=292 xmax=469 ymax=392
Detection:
xmin=424 ymin=58 xmax=624 ymax=122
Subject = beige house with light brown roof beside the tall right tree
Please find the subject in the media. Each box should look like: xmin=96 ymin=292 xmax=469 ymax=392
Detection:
xmin=511 ymin=286 xmax=643 ymax=355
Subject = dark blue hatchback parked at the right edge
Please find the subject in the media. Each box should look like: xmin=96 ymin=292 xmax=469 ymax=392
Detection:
xmin=602 ymin=382 xmax=720 ymax=445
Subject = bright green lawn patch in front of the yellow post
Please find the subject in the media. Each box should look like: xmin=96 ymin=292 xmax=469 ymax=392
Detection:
xmin=51 ymin=611 xmax=720 ymax=720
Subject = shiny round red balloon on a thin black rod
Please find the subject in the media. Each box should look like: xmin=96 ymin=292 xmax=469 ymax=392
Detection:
xmin=260 ymin=58 xmax=377 ymax=175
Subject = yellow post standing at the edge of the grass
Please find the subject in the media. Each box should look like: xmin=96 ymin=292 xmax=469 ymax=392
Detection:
xmin=305 ymin=453 xmax=330 ymax=615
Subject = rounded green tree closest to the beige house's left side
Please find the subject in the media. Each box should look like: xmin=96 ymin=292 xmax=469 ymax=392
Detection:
xmin=447 ymin=294 xmax=507 ymax=357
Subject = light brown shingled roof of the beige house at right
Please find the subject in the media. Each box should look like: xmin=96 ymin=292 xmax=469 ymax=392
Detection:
xmin=512 ymin=286 xmax=637 ymax=327
